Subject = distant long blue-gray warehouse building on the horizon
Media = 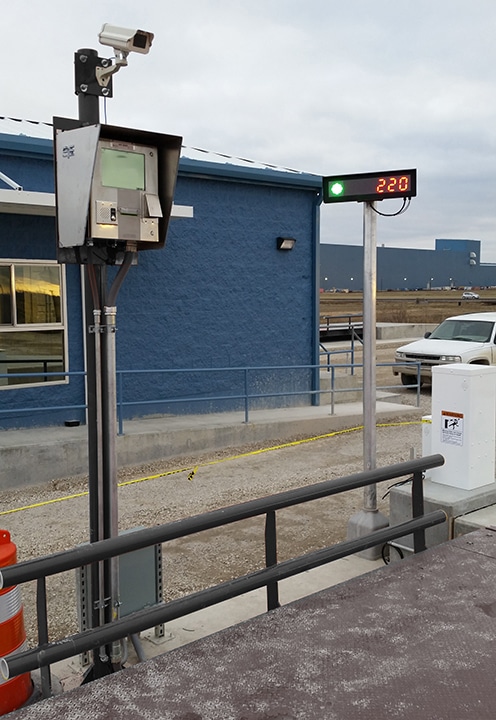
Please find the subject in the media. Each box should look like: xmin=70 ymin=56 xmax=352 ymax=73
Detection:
xmin=320 ymin=239 xmax=496 ymax=291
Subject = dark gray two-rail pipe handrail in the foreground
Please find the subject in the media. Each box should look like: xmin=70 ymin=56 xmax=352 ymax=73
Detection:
xmin=0 ymin=455 xmax=446 ymax=694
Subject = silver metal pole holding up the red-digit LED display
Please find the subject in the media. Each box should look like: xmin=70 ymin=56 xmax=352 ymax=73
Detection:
xmin=363 ymin=202 xmax=377 ymax=510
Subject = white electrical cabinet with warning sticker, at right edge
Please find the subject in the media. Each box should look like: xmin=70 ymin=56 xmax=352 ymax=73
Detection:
xmin=430 ymin=363 xmax=496 ymax=490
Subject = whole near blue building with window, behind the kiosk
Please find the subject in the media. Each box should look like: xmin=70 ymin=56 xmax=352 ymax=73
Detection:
xmin=0 ymin=123 xmax=321 ymax=428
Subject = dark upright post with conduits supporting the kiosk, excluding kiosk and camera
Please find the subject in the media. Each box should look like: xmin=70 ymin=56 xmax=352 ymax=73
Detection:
xmin=75 ymin=49 xmax=120 ymax=681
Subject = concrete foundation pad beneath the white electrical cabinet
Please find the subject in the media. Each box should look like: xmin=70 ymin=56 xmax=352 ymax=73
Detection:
xmin=389 ymin=480 xmax=496 ymax=548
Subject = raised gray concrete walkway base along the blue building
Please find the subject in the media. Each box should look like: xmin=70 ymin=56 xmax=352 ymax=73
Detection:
xmin=0 ymin=402 xmax=421 ymax=490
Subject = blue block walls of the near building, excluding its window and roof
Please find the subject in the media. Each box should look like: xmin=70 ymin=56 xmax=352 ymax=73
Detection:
xmin=0 ymin=136 xmax=320 ymax=428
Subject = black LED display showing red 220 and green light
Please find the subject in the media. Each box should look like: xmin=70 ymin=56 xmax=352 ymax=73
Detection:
xmin=323 ymin=170 xmax=417 ymax=203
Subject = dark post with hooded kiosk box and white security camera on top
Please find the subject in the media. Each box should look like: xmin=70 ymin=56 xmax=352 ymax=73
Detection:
xmin=57 ymin=28 xmax=182 ymax=682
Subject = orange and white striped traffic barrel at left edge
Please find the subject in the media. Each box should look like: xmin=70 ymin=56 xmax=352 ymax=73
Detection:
xmin=0 ymin=530 xmax=33 ymax=715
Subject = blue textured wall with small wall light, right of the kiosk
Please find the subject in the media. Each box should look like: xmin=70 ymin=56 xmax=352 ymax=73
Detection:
xmin=110 ymin=177 xmax=314 ymax=415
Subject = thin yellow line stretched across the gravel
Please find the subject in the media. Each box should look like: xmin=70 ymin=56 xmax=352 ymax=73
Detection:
xmin=0 ymin=420 xmax=423 ymax=517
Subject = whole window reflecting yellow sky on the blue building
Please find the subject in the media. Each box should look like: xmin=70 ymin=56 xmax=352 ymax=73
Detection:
xmin=0 ymin=260 xmax=65 ymax=388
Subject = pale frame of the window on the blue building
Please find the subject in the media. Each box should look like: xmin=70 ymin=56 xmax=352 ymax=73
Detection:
xmin=0 ymin=258 xmax=69 ymax=391
